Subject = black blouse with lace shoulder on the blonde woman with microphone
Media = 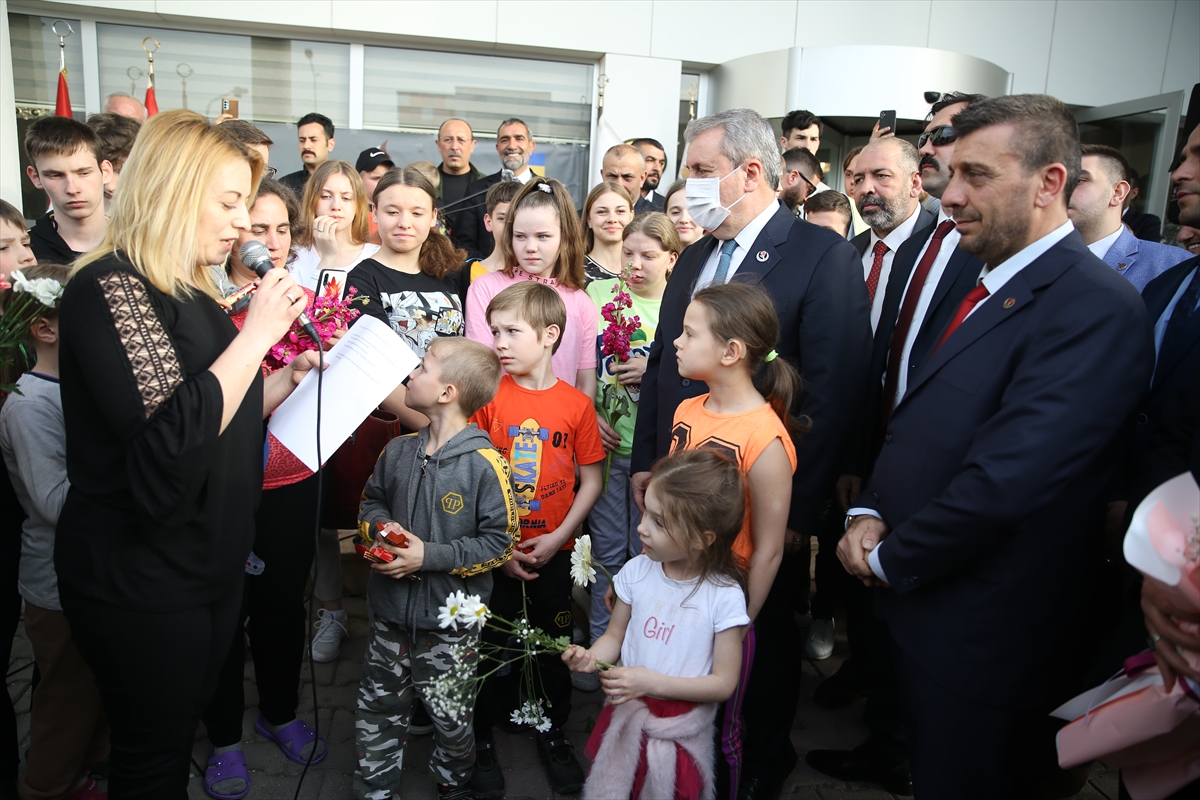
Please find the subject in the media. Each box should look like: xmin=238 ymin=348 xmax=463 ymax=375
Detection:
xmin=54 ymin=254 xmax=263 ymax=610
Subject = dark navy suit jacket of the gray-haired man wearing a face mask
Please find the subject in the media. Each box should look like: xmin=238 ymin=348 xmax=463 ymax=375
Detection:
xmin=632 ymin=205 xmax=871 ymax=533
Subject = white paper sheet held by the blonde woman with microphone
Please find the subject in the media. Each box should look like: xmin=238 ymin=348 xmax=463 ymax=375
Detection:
xmin=268 ymin=314 xmax=421 ymax=470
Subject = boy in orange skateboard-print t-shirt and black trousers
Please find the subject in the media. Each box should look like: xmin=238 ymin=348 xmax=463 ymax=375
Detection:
xmin=472 ymin=281 xmax=605 ymax=796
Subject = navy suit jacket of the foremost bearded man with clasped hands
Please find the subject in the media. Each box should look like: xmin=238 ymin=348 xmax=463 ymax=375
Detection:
xmin=854 ymin=231 xmax=1153 ymax=708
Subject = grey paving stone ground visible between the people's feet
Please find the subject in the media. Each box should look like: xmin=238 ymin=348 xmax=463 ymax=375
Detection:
xmin=8 ymin=542 xmax=1117 ymax=800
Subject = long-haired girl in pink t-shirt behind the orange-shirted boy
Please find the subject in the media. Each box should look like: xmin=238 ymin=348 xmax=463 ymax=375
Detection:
xmin=467 ymin=178 xmax=599 ymax=397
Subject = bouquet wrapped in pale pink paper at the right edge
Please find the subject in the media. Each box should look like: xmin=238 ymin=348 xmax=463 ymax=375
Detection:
xmin=1054 ymin=473 xmax=1200 ymax=800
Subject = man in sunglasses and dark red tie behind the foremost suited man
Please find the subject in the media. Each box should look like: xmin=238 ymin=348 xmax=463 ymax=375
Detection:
xmin=805 ymin=92 xmax=984 ymax=793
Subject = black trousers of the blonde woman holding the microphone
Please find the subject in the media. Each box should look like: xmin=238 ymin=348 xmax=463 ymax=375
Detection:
xmin=59 ymin=583 xmax=241 ymax=800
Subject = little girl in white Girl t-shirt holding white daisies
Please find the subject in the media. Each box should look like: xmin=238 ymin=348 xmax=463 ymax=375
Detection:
xmin=563 ymin=449 xmax=750 ymax=800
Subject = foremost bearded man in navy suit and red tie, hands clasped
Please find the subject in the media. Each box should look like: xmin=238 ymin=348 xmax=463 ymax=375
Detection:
xmin=838 ymin=95 xmax=1153 ymax=800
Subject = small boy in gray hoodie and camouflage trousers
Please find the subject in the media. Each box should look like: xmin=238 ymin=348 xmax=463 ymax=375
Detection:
xmin=354 ymin=337 xmax=521 ymax=800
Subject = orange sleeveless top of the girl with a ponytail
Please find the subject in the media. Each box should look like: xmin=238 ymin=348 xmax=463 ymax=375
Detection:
xmin=671 ymin=395 xmax=796 ymax=564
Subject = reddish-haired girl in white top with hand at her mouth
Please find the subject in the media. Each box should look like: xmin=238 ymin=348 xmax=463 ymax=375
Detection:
xmin=288 ymin=158 xmax=379 ymax=291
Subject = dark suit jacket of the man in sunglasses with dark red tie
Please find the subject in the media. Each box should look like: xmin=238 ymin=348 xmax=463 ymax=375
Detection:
xmin=842 ymin=215 xmax=983 ymax=477
